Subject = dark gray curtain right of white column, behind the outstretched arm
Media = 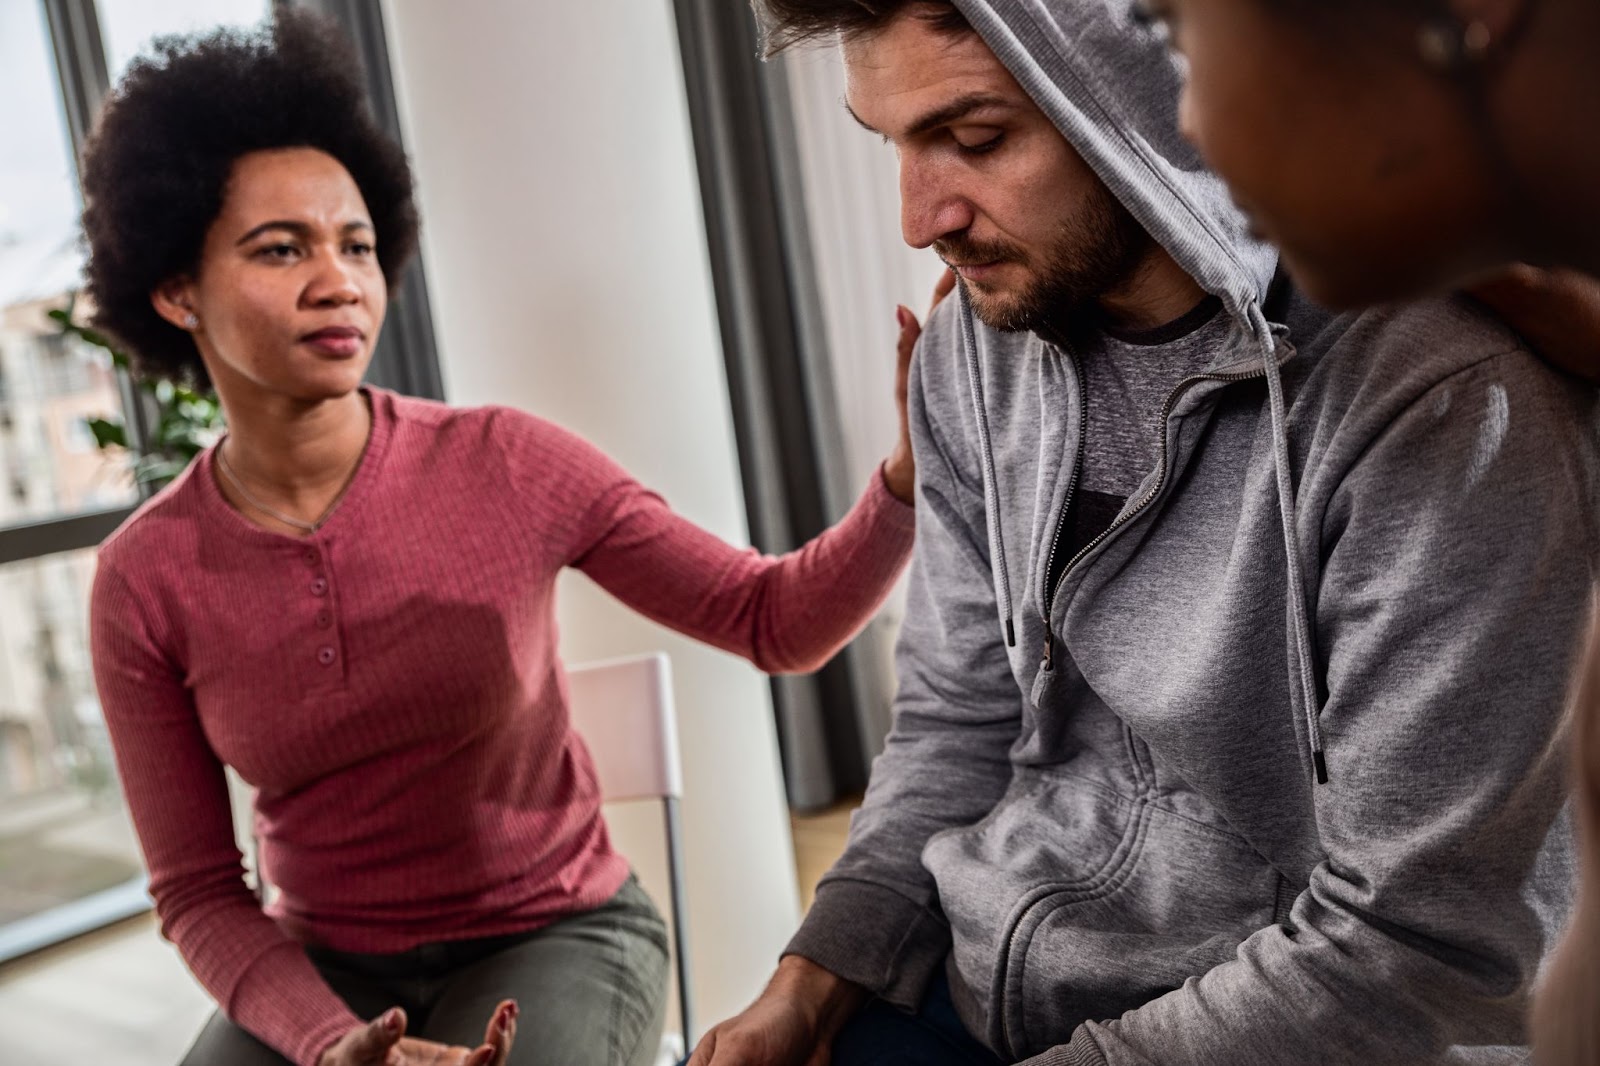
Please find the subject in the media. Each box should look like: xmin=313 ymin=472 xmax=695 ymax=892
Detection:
xmin=675 ymin=0 xmax=890 ymax=810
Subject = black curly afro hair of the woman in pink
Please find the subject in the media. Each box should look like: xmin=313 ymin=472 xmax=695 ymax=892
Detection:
xmin=82 ymin=10 xmax=418 ymax=386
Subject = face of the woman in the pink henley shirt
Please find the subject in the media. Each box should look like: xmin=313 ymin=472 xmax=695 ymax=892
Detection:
xmin=154 ymin=147 xmax=387 ymax=402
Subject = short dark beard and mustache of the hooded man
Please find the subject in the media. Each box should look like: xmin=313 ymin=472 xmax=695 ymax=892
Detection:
xmin=933 ymin=184 xmax=1154 ymax=333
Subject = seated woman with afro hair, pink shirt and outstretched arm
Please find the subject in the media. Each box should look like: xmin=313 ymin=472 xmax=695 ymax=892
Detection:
xmin=83 ymin=14 xmax=917 ymax=1066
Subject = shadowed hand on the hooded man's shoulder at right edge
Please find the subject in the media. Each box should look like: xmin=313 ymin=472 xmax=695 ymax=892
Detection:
xmin=1467 ymin=266 xmax=1600 ymax=383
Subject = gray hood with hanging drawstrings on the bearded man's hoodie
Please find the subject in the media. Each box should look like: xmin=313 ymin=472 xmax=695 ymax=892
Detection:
xmin=954 ymin=0 xmax=1326 ymax=781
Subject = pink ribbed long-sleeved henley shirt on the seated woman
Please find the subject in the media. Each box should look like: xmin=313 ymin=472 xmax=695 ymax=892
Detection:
xmin=91 ymin=389 xmax=914 ymax=1066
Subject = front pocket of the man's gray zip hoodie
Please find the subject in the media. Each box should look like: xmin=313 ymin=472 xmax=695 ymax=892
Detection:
xmin=997 ymin=804 xmax=1278 ymax=1058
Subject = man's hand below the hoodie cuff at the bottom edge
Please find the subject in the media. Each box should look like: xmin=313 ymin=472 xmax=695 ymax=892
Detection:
xmin=688 ymin=956 xmax=867 ymax=1066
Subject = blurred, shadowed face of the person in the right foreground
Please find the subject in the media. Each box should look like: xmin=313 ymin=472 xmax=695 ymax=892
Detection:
xmin=1150 ymin=0 xmax=1509 ymax=307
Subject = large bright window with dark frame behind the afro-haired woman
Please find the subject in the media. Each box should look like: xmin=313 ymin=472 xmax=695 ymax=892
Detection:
xmin=0 ymin=0 xmax=438 ymax=962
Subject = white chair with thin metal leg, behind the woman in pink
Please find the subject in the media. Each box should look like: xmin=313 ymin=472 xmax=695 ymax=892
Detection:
xmin=566 ymin=651 xmax=694 ymax=1063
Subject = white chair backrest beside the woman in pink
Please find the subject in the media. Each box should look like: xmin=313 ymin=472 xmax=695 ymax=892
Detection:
xmin=566 ymin=651 xmax=683 ymax=802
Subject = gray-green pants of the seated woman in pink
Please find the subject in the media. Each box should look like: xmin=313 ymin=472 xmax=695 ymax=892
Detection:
xmin=182 ymin=877 xmax=667 ymax=1066
